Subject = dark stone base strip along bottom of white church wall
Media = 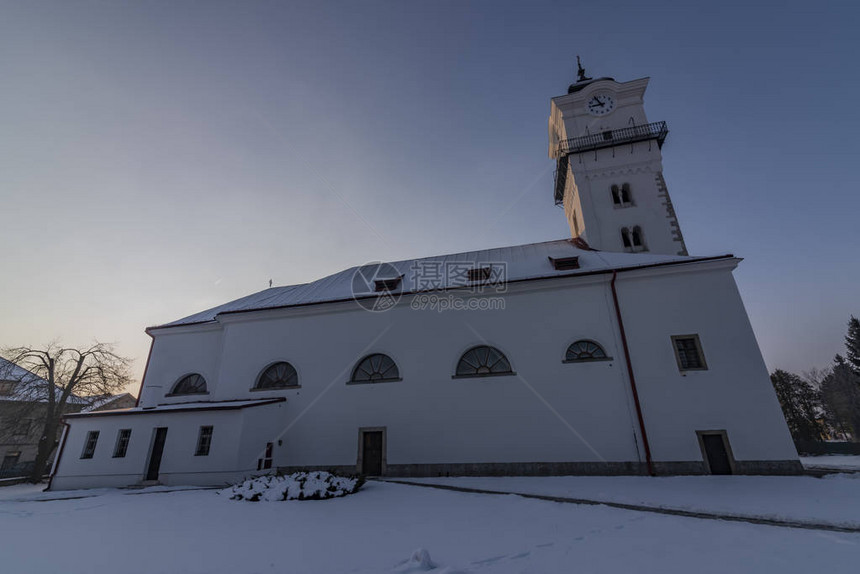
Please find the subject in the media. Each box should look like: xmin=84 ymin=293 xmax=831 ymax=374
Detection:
xmin=278 ymin=460 xmax=803 ymax=478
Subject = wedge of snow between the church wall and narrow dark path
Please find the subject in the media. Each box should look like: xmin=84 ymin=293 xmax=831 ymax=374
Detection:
xmin=410 ymin=474 xmax=860 ymax=527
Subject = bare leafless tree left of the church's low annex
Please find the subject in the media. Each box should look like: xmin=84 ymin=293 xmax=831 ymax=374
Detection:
xmin=0 ymin=342 xmax=131 ymax=482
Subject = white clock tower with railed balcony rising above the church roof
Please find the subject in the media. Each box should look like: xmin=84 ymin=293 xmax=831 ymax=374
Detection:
xmin=549 ymin=57 xmax=687 ymax=255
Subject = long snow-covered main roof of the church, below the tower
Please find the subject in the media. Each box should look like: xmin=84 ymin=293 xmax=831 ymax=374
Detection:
xmin=149 ymin=239 xmax=731 ymax=329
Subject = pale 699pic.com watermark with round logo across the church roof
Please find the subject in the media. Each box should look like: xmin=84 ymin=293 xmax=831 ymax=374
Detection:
xmin=352 ymin=259 xmax=508 ymax=313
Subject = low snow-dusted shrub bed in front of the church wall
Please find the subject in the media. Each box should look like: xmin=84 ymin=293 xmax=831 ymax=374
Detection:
xmin=219 ymin=471 xmax=364 ymax=502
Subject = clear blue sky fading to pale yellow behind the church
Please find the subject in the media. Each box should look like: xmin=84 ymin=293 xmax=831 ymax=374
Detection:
xmin=0 ymin=1 xmax=860 ymax=394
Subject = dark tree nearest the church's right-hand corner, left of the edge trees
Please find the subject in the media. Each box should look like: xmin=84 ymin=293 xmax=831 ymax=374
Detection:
xmin=770 ymin=369 xmax=824 ymax=441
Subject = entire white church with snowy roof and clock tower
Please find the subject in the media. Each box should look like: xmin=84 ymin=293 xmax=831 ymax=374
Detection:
xmin=50 ymin=66 xmax=801 ymax=489
